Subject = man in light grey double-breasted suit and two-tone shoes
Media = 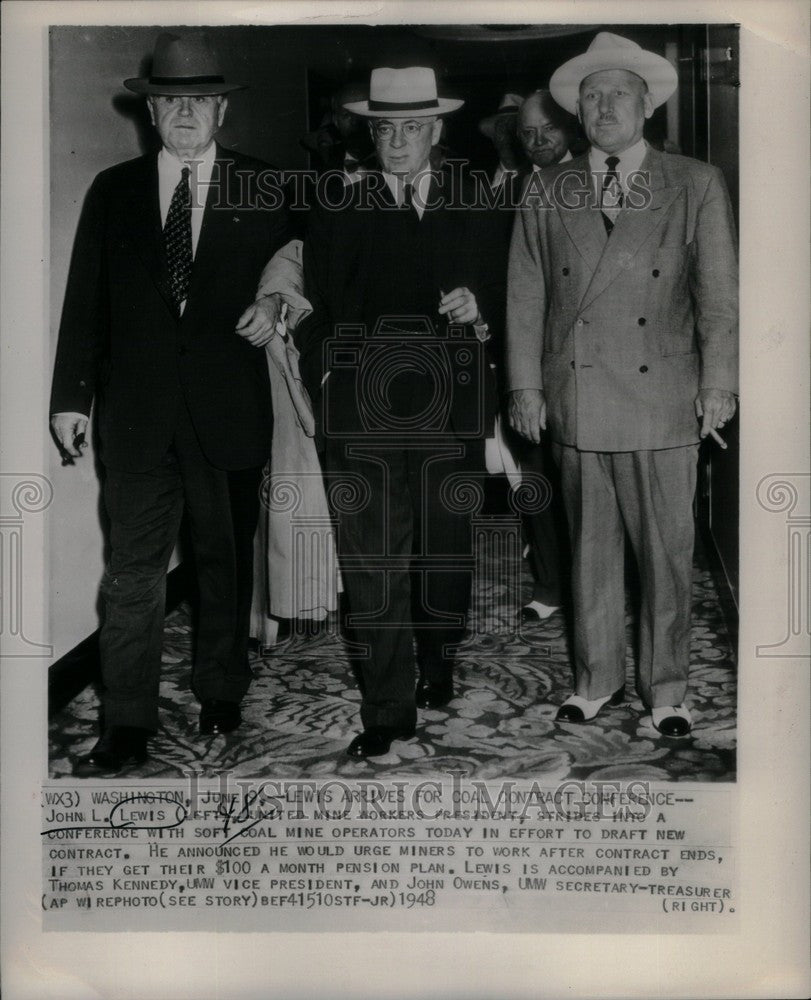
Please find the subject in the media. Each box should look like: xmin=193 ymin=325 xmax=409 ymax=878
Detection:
xmin=507 ymin=33 xmax=737 ymax=737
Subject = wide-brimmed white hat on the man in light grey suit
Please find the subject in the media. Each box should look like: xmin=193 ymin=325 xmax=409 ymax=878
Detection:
xmin=549 ymin=31 xmax=679 ymax=114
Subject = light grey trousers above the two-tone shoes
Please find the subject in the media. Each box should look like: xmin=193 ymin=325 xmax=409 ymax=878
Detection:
xmin=555 ymin=445 xmax=698 ymax=708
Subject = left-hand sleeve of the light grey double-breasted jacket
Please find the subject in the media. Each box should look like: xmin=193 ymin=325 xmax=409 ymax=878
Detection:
xmin=505 ymin=193 xmax=547 ymax=391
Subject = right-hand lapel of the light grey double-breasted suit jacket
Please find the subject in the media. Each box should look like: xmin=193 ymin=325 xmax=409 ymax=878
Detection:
xmin=580 ymin=149 xmax=681 ymax=309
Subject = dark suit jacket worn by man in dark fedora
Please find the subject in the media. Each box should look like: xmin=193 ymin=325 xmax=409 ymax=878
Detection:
xmin=51 ymin=146 xmax=287 ymax=472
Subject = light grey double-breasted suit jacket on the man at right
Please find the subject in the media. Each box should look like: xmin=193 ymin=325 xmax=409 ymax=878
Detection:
xmin=507 ymin=148 xmax=738 ymax=452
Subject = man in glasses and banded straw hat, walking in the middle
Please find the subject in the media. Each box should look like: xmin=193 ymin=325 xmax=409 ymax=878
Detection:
xmin=295 ymin=67 xmax=498 ymax=758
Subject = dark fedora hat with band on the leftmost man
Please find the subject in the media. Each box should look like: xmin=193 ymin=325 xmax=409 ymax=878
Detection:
xmin=124 ymin=32 xmax=245 ymax=97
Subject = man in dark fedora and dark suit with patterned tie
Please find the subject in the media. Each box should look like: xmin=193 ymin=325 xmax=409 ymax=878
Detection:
xmin=51 ymin=33 xmax=287 ymax=776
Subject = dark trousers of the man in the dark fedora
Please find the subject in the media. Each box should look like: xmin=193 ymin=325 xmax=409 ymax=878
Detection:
xmin=100 ymin=406 xmax=261 ymax=730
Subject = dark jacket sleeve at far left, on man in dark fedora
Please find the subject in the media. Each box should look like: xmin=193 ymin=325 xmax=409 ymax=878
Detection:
xmin=50 ymin=177 xmax=109 ymax=414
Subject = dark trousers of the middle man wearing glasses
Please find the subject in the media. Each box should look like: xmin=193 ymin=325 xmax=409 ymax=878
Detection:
xmin=325 ymin=438 xmax=481 ymax=729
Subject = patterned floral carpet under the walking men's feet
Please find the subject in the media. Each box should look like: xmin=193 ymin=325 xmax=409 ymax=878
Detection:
xmin=50 ymin=532 xmax=736 ymax=783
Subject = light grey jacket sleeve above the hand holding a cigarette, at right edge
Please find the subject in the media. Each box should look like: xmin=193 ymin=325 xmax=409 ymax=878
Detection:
xmin=690 ymin=168 xmax=738 ymax=392
